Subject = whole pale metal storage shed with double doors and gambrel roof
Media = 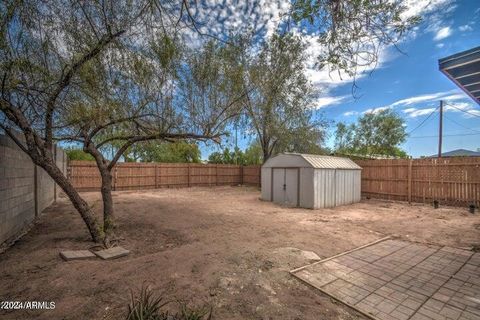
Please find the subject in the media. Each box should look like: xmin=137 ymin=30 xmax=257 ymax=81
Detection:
xmin=261 ymin=153 xmax=362 ymax=209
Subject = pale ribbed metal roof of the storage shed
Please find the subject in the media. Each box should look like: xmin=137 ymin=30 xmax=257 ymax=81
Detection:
xmin=263 ymin=153 xmax=362 ymax=170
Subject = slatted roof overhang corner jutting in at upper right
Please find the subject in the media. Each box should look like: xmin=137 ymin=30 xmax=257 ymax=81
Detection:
xmin=438 ymin=47 xmax=480 ymax=104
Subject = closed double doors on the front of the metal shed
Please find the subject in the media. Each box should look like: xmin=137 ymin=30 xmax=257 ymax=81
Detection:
xmin=272 ymin=168 xmax=298 ymax=206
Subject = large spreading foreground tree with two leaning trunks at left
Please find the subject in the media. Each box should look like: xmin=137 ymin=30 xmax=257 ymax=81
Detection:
xmin=0 ymin=0 xmax=243 ymax=246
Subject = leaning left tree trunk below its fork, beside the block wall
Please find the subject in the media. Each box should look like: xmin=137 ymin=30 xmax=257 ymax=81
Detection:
xmin=41 ymin=161 xmax=104 ymax=243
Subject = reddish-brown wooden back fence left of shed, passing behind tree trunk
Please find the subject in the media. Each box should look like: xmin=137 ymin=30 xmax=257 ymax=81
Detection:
xmin=68 ymin=161 xmax=260 ymax=191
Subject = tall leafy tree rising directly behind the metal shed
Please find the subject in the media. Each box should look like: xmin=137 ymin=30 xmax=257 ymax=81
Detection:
xmin=245 ymin=34 xmax=327 ymax=161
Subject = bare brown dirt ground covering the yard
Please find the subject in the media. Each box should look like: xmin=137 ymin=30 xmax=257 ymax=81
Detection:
xmin=0 ymin=187 xmax=480 ymax=319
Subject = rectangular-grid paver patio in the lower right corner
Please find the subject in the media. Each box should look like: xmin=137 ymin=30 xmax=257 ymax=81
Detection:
xmin=292 ymin=239 xmax=480 ymax=320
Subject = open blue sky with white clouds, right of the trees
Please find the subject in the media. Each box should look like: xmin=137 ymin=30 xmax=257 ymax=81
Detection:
xmin=202 ymin=0 xmax=480 ymax=158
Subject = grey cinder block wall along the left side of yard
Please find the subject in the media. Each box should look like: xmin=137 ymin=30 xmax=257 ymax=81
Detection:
xmin=0 ymin=133 xmax=67 ymax=245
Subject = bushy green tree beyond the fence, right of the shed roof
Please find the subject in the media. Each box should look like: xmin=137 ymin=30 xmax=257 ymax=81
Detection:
xmin=335 ymin=109 xmax=407 ymax=158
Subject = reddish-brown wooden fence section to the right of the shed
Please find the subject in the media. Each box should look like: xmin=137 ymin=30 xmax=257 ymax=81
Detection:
xmin=355 ymin=157 xmax=480 ymax=207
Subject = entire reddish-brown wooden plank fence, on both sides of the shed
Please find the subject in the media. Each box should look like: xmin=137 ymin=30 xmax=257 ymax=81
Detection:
xmin=68 ymin=157 xmax=480 ymax=207
